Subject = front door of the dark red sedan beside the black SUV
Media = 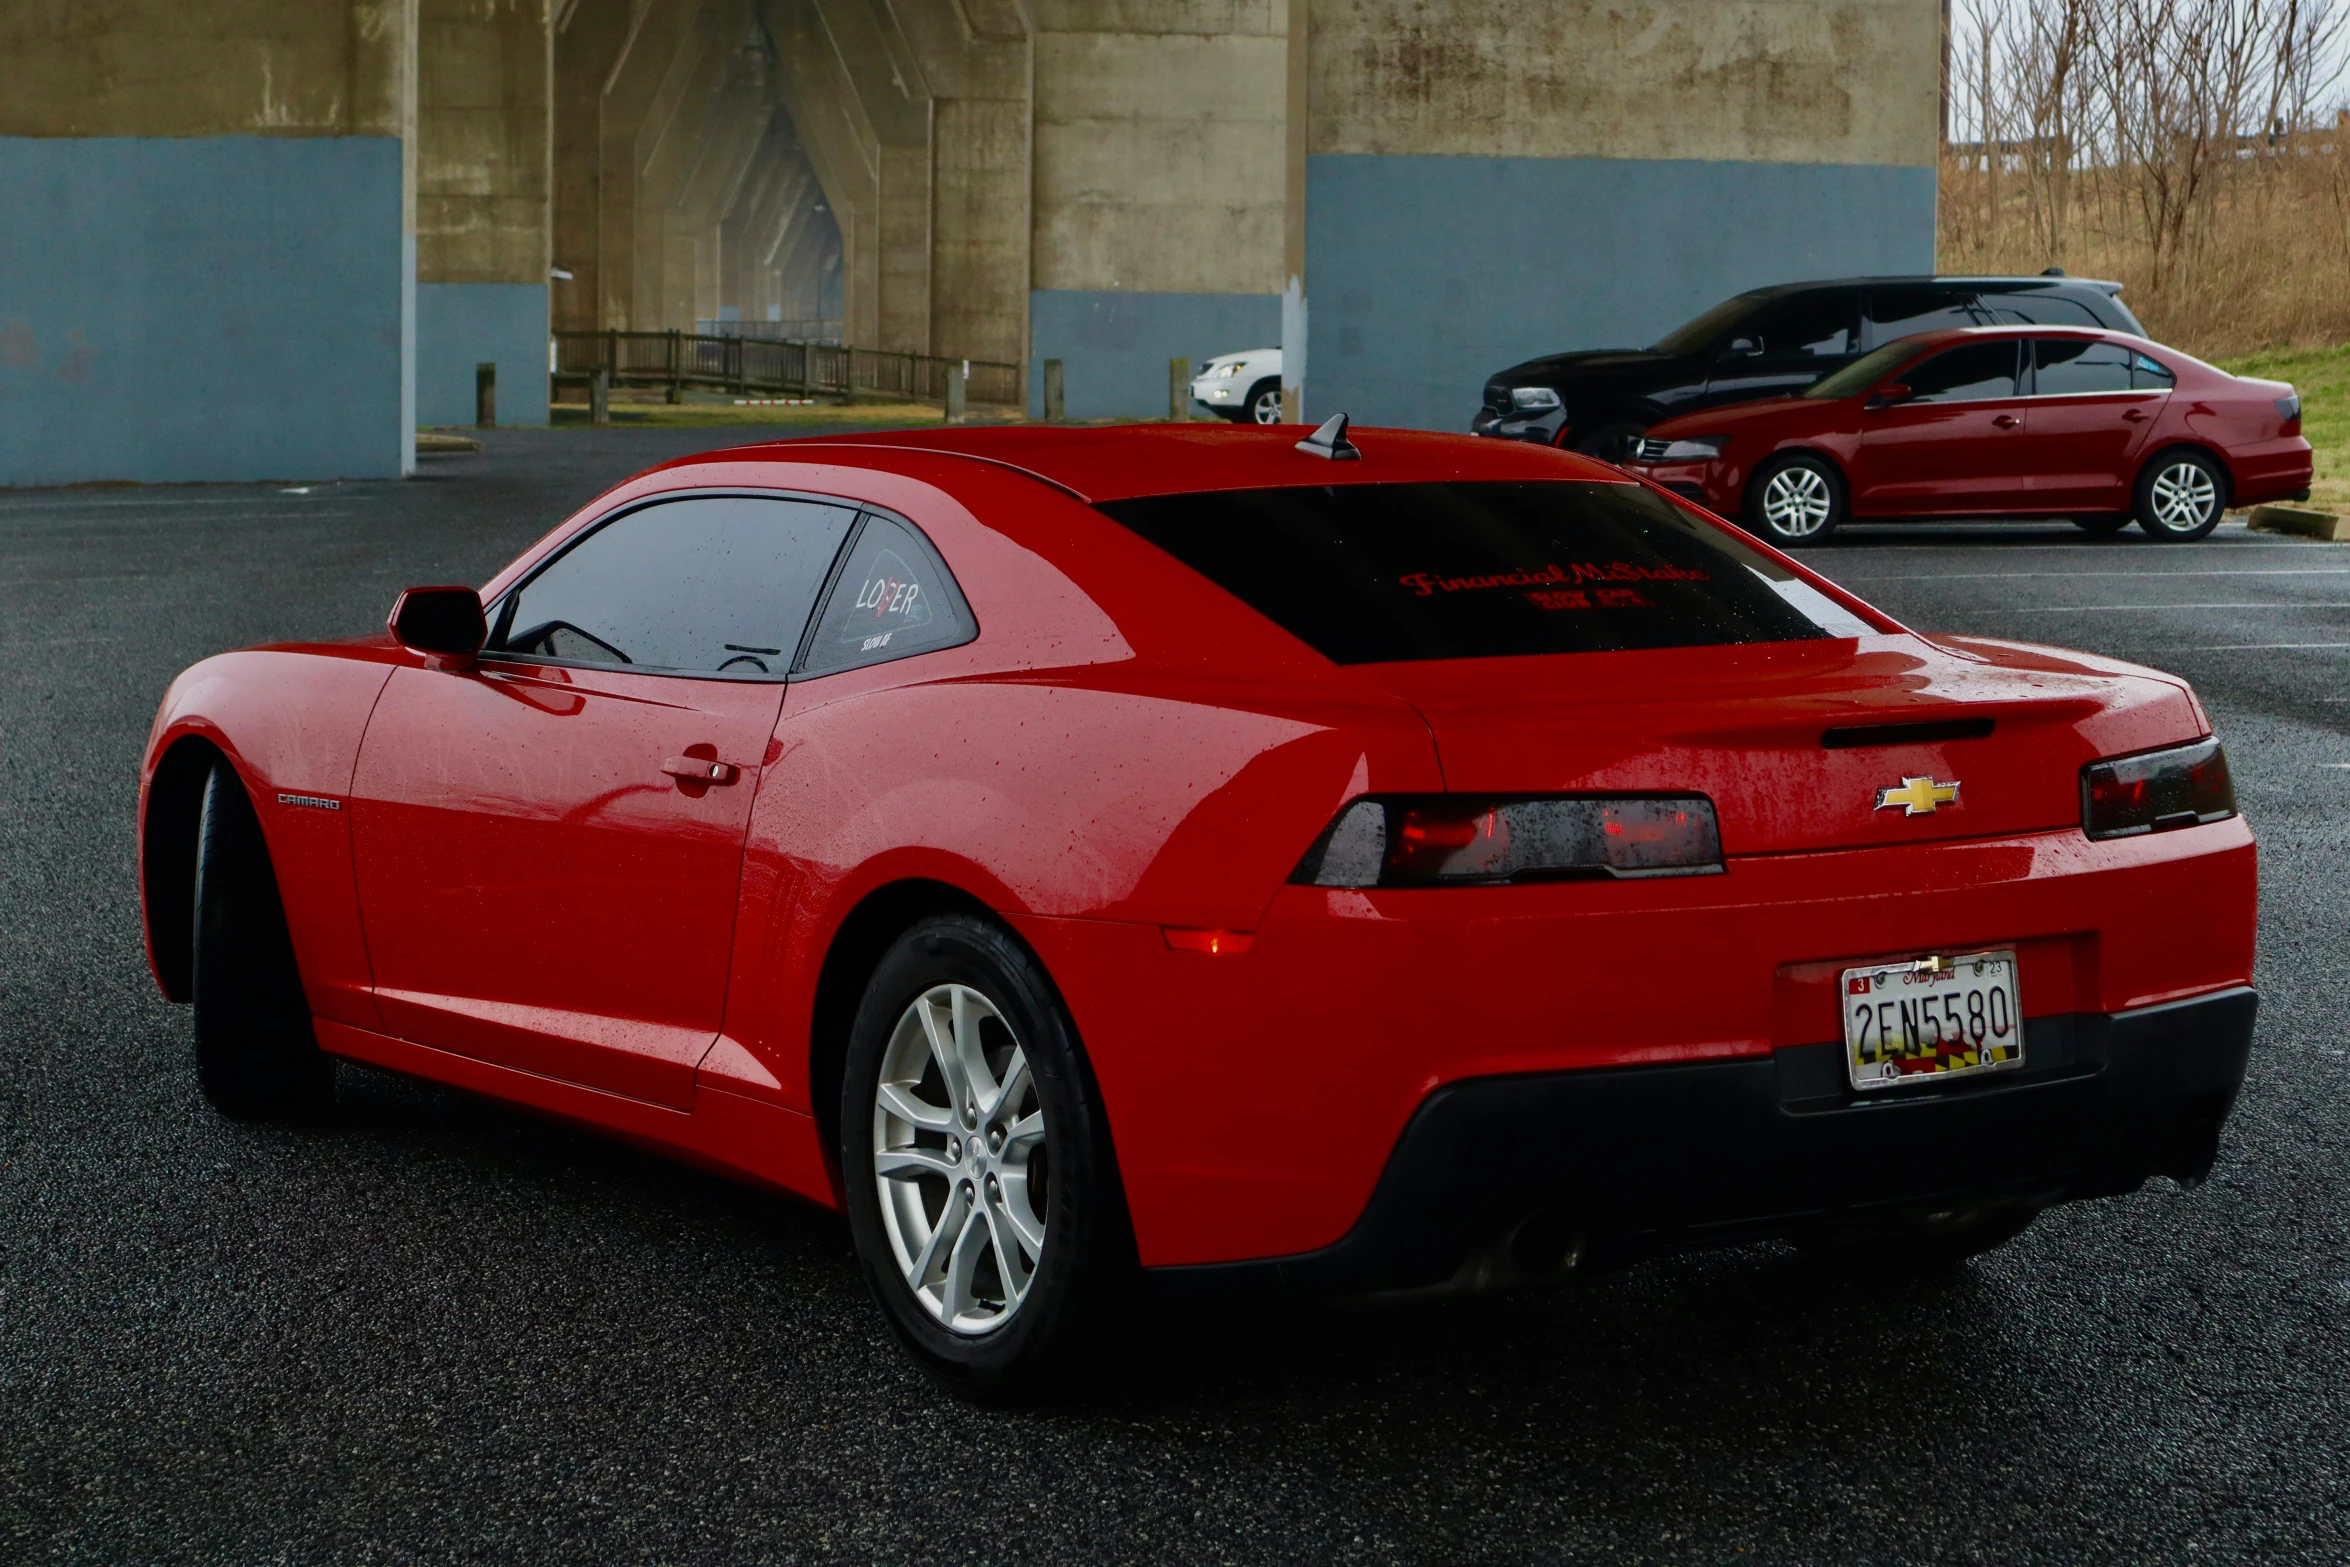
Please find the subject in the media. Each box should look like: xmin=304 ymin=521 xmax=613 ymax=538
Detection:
xmin=1852 ymin=338 xmax=2026 ymax=517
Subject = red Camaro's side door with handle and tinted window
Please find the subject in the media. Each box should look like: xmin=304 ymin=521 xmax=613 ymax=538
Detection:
xmin=350 ymin=496 xmax=855 ymax=1109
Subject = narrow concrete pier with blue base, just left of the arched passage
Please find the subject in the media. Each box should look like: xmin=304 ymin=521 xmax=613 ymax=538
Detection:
xmin=416 ymin=0 xmax=555 ymax=425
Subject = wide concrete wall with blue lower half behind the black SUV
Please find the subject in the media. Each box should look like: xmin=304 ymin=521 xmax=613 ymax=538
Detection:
xmin=1290 ymin=0 xmax=1941 ymax=428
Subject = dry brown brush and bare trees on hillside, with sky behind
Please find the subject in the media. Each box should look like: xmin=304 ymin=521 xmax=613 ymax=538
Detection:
xmin=1939 ymin=0 xmax=2350 ymax=357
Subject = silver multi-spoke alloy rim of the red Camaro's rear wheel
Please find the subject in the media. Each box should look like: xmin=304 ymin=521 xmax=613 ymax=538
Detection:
xmin=872 ymin=984 xmax=1050 ymax=1334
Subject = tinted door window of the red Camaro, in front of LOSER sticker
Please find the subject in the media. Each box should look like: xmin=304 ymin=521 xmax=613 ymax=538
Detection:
xmin=484 ymin=496 xmax=855 ymax=679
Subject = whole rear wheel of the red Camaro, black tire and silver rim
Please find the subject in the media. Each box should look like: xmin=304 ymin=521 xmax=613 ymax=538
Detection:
xmin=839 ymin=914 xmax=1130 ymax=1403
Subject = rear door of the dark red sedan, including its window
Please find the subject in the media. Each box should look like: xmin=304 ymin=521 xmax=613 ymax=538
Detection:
xmin=2014 ymin=336 xmax=2171 ymax=512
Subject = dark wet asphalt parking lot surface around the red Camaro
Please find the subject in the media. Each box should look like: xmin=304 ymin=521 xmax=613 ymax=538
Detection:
xmin=0 ymin=430 xmax=2350 ymax=1565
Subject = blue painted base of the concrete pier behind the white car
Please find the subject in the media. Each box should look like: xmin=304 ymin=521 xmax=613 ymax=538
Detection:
xmin=1029 ymin=289 xmax=1281 ymax=418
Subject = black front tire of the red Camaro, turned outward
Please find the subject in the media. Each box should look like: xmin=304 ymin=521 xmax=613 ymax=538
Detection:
xmin=190 ymin=761 xmax=334 ymax=1121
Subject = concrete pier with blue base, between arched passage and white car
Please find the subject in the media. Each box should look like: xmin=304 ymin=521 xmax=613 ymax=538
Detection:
xmin=1029 ymin=0 xmax=1288 ymax=418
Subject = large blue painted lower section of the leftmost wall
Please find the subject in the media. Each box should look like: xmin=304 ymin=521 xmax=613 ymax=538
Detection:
xmin=0 ymin=136 xmax=408 ymax=484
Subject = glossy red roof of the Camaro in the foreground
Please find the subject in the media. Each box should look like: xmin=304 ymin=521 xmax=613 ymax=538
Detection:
xmin=686 ymin=423 xmax=1631 ymax=503
